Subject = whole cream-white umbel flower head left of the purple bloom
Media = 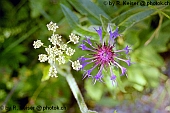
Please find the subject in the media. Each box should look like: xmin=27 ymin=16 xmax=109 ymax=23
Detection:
xmin=33 ymin=21 xmax=82 ymax=77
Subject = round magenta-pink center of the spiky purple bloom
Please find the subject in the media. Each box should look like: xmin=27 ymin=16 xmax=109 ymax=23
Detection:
xmin=94 ymin=45 xmax=115 ymax=65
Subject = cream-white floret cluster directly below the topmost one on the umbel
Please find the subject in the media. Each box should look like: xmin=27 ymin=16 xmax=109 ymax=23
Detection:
xmin=48 ymin=34 xmax=62 ymax=46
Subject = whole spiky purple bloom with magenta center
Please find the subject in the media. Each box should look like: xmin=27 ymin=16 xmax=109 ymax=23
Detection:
xmin=79 ymin=25 xmax=131 ymax=85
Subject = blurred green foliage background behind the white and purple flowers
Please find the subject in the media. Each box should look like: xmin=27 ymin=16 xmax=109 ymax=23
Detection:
xmin=0 ymin=0 xmax=170 ymax=113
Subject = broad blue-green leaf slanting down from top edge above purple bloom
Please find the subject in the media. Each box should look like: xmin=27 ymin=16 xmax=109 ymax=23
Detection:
xmin=69 ymin=0 xmax=109 ymax=24
